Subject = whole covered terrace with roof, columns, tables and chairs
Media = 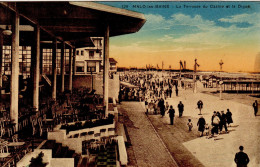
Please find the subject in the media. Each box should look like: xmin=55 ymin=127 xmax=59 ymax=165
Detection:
xmin=0 ymin=2 xmax=145 ymax=167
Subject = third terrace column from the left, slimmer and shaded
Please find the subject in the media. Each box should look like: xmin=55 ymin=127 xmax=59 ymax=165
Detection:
xmin=51 ymin=39 xmax=57 ymax=101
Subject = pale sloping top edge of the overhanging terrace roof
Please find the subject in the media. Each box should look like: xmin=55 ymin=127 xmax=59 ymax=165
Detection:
xmin=69 ymin=1 xmax=146 ymax=20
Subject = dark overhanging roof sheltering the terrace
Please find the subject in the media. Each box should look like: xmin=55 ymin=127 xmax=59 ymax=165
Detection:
xmin=0 ymin=1 xmax=146 ymax=48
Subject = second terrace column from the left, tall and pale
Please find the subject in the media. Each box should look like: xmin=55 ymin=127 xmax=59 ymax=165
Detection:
xmin=31 ymin=25 xmax=40 ymax=111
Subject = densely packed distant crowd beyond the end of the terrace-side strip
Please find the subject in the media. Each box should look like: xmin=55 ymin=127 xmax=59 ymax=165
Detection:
xmin=119 ymin=73 xmax=179 ymax=103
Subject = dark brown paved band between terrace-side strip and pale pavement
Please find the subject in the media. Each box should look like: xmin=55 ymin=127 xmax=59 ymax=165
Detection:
xmin=148 ymin=115 xmax=204 ymax=167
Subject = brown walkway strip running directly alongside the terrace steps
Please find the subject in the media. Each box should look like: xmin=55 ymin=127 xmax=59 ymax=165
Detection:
xmin=118 ymin=102 xmax=177 ymax=167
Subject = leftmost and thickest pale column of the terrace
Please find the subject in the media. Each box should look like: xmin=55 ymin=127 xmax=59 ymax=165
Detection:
xmin=10 ymin=13 xmax=20 ymax=131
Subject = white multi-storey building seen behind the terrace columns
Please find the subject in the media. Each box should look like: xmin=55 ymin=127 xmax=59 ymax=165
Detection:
xmin=75 ymin=37 xmax=104 ymax=75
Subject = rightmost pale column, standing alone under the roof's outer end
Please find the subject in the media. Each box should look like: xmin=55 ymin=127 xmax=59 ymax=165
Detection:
xmin=103 ymin=26 xmax=109 ymax=116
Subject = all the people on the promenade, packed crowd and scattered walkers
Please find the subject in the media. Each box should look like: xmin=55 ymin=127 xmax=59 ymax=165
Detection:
xmin=119 ymin=73 xmax=258 ymax=166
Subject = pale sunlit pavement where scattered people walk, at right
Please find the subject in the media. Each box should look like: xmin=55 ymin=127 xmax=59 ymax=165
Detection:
xmin=161 ymin=90 xmax=260 ymax=167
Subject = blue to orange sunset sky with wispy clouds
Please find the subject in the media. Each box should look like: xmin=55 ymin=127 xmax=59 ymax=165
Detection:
xmin=98 ymin=2 xmax=260 ymax=72
